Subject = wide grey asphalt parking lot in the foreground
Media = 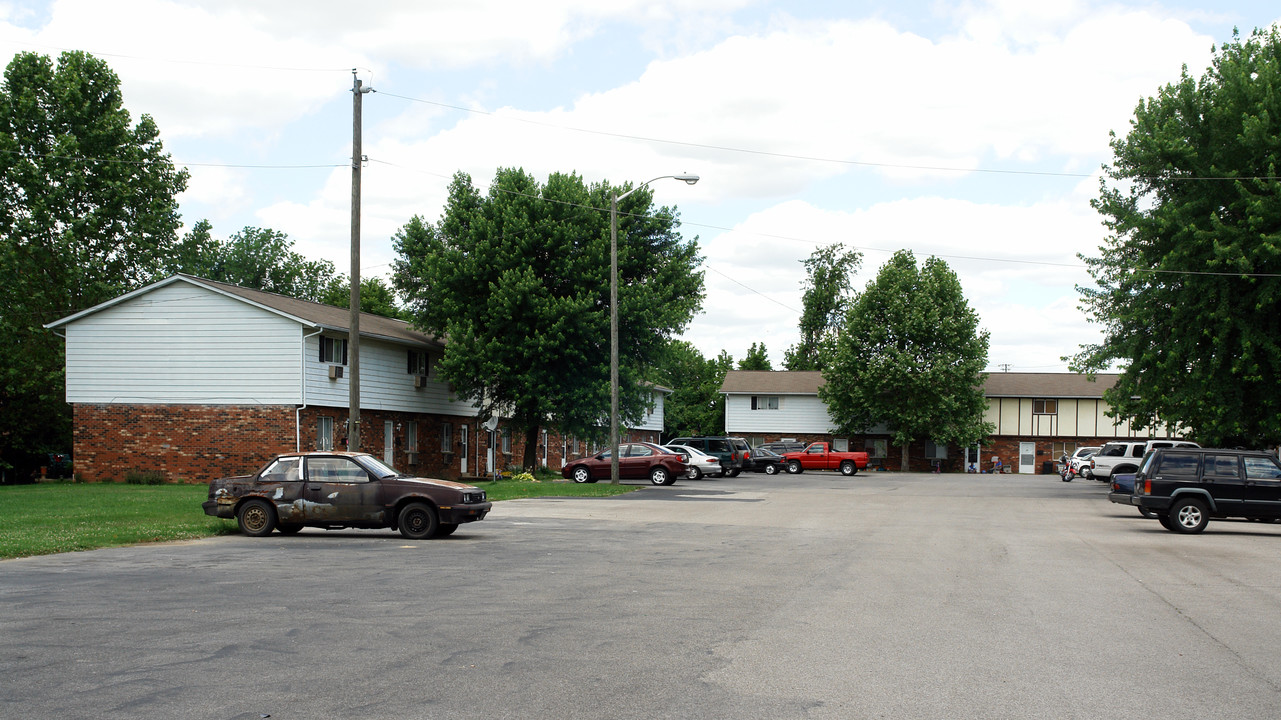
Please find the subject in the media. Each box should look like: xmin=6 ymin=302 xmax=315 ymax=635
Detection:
xmin=0 ymin=473 xmax=1281 ymax=719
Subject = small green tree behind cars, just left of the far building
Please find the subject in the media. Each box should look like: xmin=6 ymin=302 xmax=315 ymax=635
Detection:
xmin=655 ymin=340 xmax=734 ymax=439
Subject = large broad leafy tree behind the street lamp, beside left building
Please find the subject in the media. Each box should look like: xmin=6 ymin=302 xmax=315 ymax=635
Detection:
xmin=393 ymin=169 xmax=703 ymax=466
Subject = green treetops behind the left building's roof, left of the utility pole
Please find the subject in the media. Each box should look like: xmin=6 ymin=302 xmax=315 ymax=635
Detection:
xmin=168 ymin=220 xmax=340 ymax=302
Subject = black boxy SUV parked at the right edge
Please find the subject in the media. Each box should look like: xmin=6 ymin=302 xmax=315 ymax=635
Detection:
xmin=1130 ymin=447 xmax=1281 ymax=533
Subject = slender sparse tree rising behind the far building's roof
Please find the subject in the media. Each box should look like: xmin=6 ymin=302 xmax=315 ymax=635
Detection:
xmin=783 ymin=242 xmax=863 ymax=370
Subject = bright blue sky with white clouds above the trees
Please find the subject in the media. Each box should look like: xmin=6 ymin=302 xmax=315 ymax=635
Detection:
xmin=0 ymin=0 xmax=1281 ymax=372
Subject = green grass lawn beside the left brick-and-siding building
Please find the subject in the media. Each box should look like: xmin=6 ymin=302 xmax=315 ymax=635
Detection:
xmin=0 ymin=482 xmax=639 ymax=560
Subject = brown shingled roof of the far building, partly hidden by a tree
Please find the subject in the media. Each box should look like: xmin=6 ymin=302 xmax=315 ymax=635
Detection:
xmin=720 ymin=370 xmax=1117 ymax=398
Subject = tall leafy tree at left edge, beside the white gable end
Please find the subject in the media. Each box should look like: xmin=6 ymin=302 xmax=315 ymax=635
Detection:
xmin=0 ymin=53 xmax=187 ymax=474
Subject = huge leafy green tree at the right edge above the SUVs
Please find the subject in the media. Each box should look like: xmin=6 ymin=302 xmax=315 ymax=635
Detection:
xmin=1072 ymin=27 xmax=1281 ymax=447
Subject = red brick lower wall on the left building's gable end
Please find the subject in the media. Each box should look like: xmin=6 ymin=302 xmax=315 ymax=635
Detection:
xmin=72 ymin=404 xmax=293 ymax=482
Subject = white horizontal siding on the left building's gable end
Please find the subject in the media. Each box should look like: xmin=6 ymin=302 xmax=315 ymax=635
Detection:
xmin=65 ymin=283 xmax=302 ymax=405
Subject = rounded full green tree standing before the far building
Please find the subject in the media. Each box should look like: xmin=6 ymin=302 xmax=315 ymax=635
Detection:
xmin=819 ymin=250 xmax=993 ymax=470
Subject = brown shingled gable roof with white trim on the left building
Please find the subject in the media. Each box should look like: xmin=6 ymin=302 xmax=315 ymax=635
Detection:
xmin=45 ymin=273 xmax=443 ymax=347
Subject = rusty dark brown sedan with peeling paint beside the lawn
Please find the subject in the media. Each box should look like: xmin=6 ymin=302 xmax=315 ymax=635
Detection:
xmin=202 ymin=452 xmax=492 ymax=539
